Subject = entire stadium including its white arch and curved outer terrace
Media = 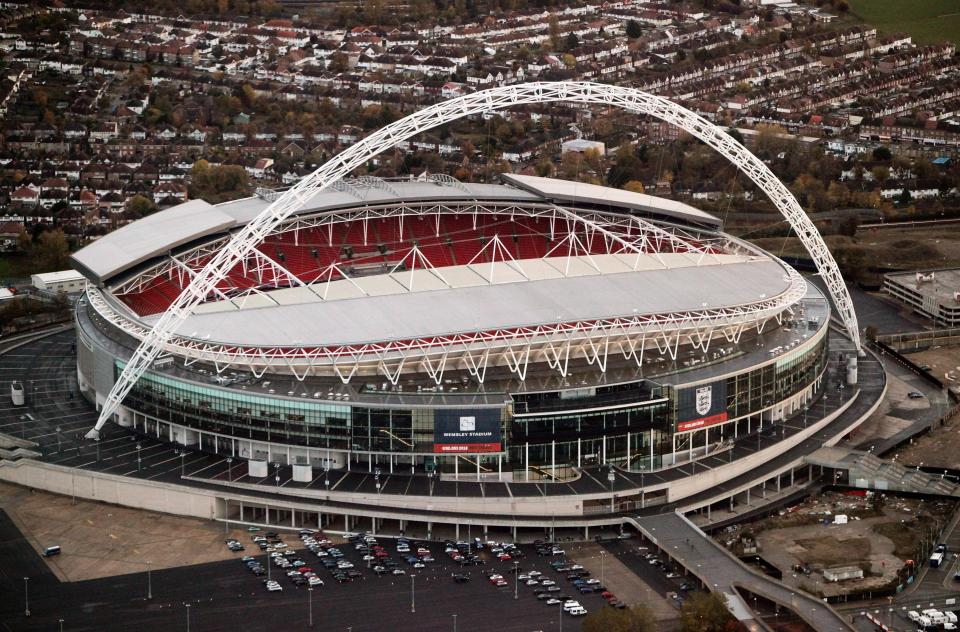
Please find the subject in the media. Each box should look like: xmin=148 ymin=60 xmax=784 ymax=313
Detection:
xmin=56 ymin=83 xmax=884 ymax=534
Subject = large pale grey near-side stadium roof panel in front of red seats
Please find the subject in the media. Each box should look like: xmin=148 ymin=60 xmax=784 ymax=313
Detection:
xmin=150 ymin=259 xmax=790 ymax=346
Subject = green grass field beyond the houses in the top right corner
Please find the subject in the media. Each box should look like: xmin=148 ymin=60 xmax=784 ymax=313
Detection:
xmin=848 ymin=0 xmax=960 ymax=44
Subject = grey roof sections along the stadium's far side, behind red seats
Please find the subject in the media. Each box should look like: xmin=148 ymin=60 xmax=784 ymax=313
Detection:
xmin=71 ymin=174 xmax=720 ymax=285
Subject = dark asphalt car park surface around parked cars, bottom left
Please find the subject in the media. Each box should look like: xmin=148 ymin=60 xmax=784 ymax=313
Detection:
xmin=0 ymin=514 xmax=624 ymax=632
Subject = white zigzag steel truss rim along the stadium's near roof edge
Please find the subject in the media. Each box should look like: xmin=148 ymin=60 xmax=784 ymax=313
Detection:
xmin=87 ymin=270 xmax=806 ymax=385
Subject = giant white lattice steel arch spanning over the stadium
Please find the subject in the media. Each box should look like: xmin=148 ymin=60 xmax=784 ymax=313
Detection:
xmin=87 ymin=81 xmax=860 ymax=438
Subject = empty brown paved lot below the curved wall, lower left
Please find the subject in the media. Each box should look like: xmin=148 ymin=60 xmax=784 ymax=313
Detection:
xmin=0 ymin=483 xmax=259 ymax=581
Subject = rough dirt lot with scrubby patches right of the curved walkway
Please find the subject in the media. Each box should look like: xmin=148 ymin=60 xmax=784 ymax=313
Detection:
xmin=718 ymin=493 xmax=952 ymax=595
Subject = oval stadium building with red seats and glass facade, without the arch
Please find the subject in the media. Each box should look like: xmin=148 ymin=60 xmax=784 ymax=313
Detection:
xmin=73 ymin=170 xmax=830 ymax=481
